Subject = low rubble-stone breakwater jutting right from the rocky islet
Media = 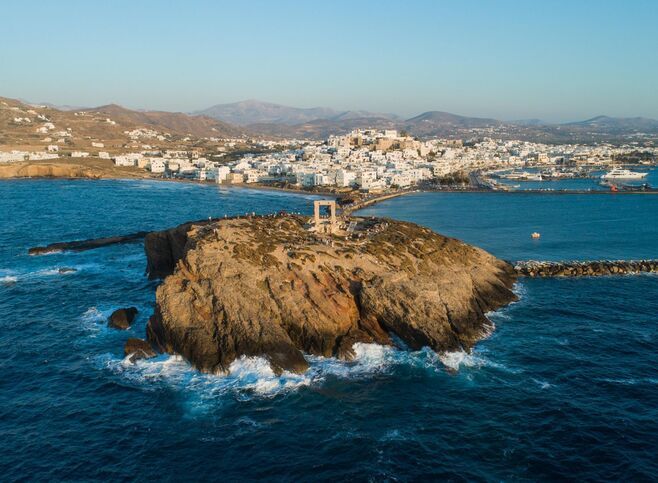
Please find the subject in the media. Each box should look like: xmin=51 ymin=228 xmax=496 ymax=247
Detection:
xmin=514 ymin=260 xmax=658 ymax=277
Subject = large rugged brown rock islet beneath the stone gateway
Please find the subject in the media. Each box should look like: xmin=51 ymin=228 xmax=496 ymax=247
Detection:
xmin=145 ymin=216 xmax=515 ymax=372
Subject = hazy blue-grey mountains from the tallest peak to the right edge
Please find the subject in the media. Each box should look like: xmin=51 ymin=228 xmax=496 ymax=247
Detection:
xmin=195 ymin=100 xmax=658 ymax=143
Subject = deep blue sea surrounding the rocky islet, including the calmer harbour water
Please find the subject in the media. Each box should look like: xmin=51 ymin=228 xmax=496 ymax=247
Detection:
xmin=0 ymin=180 xmax=658 ymax=481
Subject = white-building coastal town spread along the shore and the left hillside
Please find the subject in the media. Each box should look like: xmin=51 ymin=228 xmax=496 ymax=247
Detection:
xmin=0 ymin=97 xmax=658 ymax=194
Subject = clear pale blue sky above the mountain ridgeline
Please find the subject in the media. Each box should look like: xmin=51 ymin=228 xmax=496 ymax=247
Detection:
xmin=0 ymin=0 xmax=658 ymax=121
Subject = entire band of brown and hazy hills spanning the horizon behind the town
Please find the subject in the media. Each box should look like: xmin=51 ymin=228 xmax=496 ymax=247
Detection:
xmin=5 ymin=98 xmax=658 ymax=144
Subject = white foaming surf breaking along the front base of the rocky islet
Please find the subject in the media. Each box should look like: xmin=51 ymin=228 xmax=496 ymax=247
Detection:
xmin=95 ymin=342 xmax=514 ymax=411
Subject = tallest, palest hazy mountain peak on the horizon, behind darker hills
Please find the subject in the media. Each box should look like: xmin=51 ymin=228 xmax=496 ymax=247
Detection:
xmin=194 ymin=99 xmax=395 ymax=126
